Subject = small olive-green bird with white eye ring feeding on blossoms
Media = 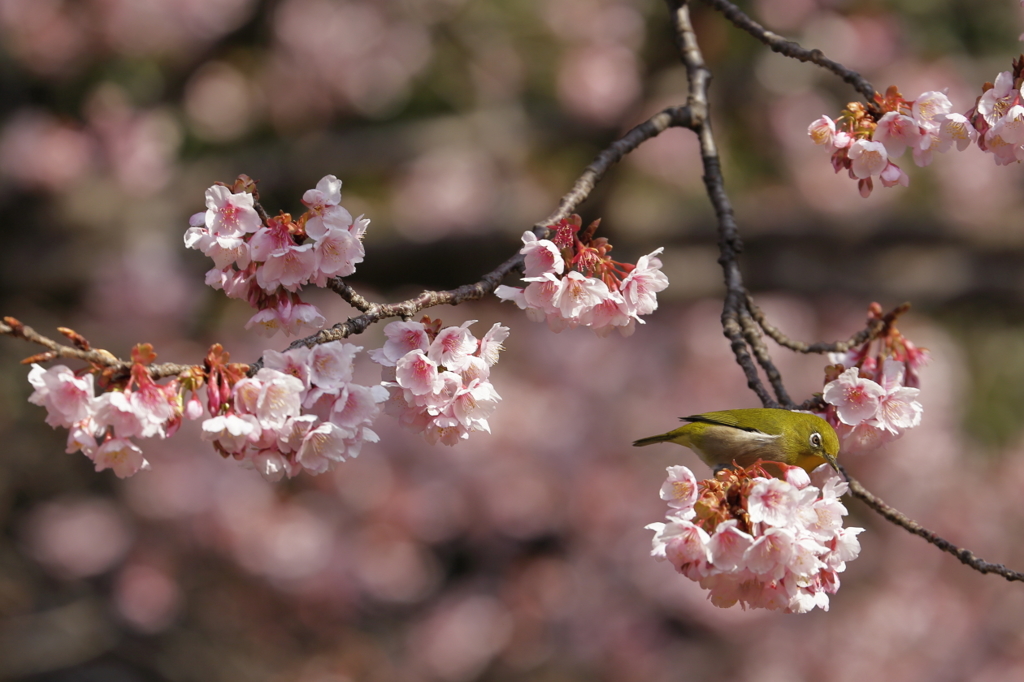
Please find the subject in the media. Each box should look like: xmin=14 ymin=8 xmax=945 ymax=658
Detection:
xmin=633 ymin=408 xmax=839 ymax=472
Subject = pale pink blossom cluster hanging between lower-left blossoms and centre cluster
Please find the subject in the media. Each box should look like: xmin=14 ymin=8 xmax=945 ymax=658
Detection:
xmin=370 ymin=317 xmax=509 ymax=445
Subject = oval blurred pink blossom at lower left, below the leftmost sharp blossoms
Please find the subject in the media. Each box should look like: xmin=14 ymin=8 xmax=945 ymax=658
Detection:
xmin=25 ymin=498 xmax=132 ymax=578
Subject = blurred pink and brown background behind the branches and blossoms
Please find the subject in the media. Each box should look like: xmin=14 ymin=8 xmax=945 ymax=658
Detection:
xmin=0 ymin=0 xmax=1024 ymax=682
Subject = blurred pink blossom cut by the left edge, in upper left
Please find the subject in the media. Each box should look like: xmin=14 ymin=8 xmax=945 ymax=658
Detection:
xmin=0 ymin=110 xmax=95 ymax=190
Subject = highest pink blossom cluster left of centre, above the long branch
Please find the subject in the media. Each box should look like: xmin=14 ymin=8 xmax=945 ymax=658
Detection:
xmin=184 ymin=175 xmax=370 ymax=336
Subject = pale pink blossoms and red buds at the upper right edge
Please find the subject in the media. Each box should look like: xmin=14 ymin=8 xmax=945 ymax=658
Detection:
xmin=807 ymin=55 xmax=1024 ymax=197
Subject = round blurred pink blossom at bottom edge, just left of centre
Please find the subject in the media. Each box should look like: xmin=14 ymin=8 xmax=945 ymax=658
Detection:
xmin=410 ymin=595 xmax=512 ymax=680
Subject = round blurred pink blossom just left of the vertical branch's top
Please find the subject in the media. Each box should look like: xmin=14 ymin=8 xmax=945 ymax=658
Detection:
xmin=558 ymin=44 xmax=641 ymax=126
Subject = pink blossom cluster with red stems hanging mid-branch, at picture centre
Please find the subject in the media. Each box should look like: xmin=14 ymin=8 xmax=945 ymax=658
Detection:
xmin=495 ymin=215 xmax=669 ymax=336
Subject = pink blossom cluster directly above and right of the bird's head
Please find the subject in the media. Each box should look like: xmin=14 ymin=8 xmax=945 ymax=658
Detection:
xmin=821 ymin=303 xmax=929 ymax=454
